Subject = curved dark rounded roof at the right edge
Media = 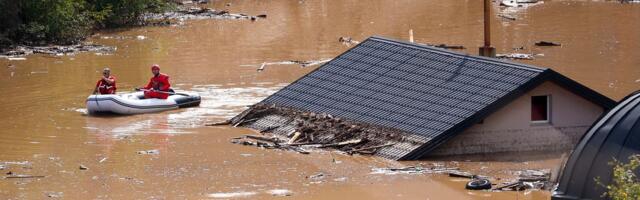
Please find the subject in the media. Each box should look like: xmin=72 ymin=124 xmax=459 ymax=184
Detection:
xmin=552 ymin=92 xmax=640 ymax=199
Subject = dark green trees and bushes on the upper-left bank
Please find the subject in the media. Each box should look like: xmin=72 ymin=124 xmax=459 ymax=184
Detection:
xmin=0 ymin=0 xmax=174 ymax=49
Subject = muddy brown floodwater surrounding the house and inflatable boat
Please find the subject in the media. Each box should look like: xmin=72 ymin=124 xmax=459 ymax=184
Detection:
xmin=0 ymin=0 xmax=640 ymax=199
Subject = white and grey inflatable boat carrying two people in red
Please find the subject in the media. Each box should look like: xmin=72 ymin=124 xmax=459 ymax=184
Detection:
xmin=87 ymin=92 xmax=200 ymax=115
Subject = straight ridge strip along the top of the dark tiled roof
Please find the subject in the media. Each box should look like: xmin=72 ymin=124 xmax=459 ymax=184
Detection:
xmin=365 ymin=36 xmax=551 ymax=72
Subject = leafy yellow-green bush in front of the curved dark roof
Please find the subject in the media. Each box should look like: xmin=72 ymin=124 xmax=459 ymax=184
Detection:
xmin=597 ymin=155 xmax=640 ymax=200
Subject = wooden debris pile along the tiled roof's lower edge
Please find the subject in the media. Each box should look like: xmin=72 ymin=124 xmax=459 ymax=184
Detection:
xmin=209 ymin=104 xmax=416 ymax=154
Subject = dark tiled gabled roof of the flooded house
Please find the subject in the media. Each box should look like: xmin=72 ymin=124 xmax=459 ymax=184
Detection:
xmin=263 ymin=37 xmax=614 ymax=159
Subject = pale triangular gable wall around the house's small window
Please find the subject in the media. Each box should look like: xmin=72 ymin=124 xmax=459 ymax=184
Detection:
xmin=429 ymin=81 xmax=604 ymax=156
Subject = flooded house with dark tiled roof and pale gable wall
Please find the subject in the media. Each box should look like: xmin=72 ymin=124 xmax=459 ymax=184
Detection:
xmin=235 ymin=37 xmax=615 ymax=160
